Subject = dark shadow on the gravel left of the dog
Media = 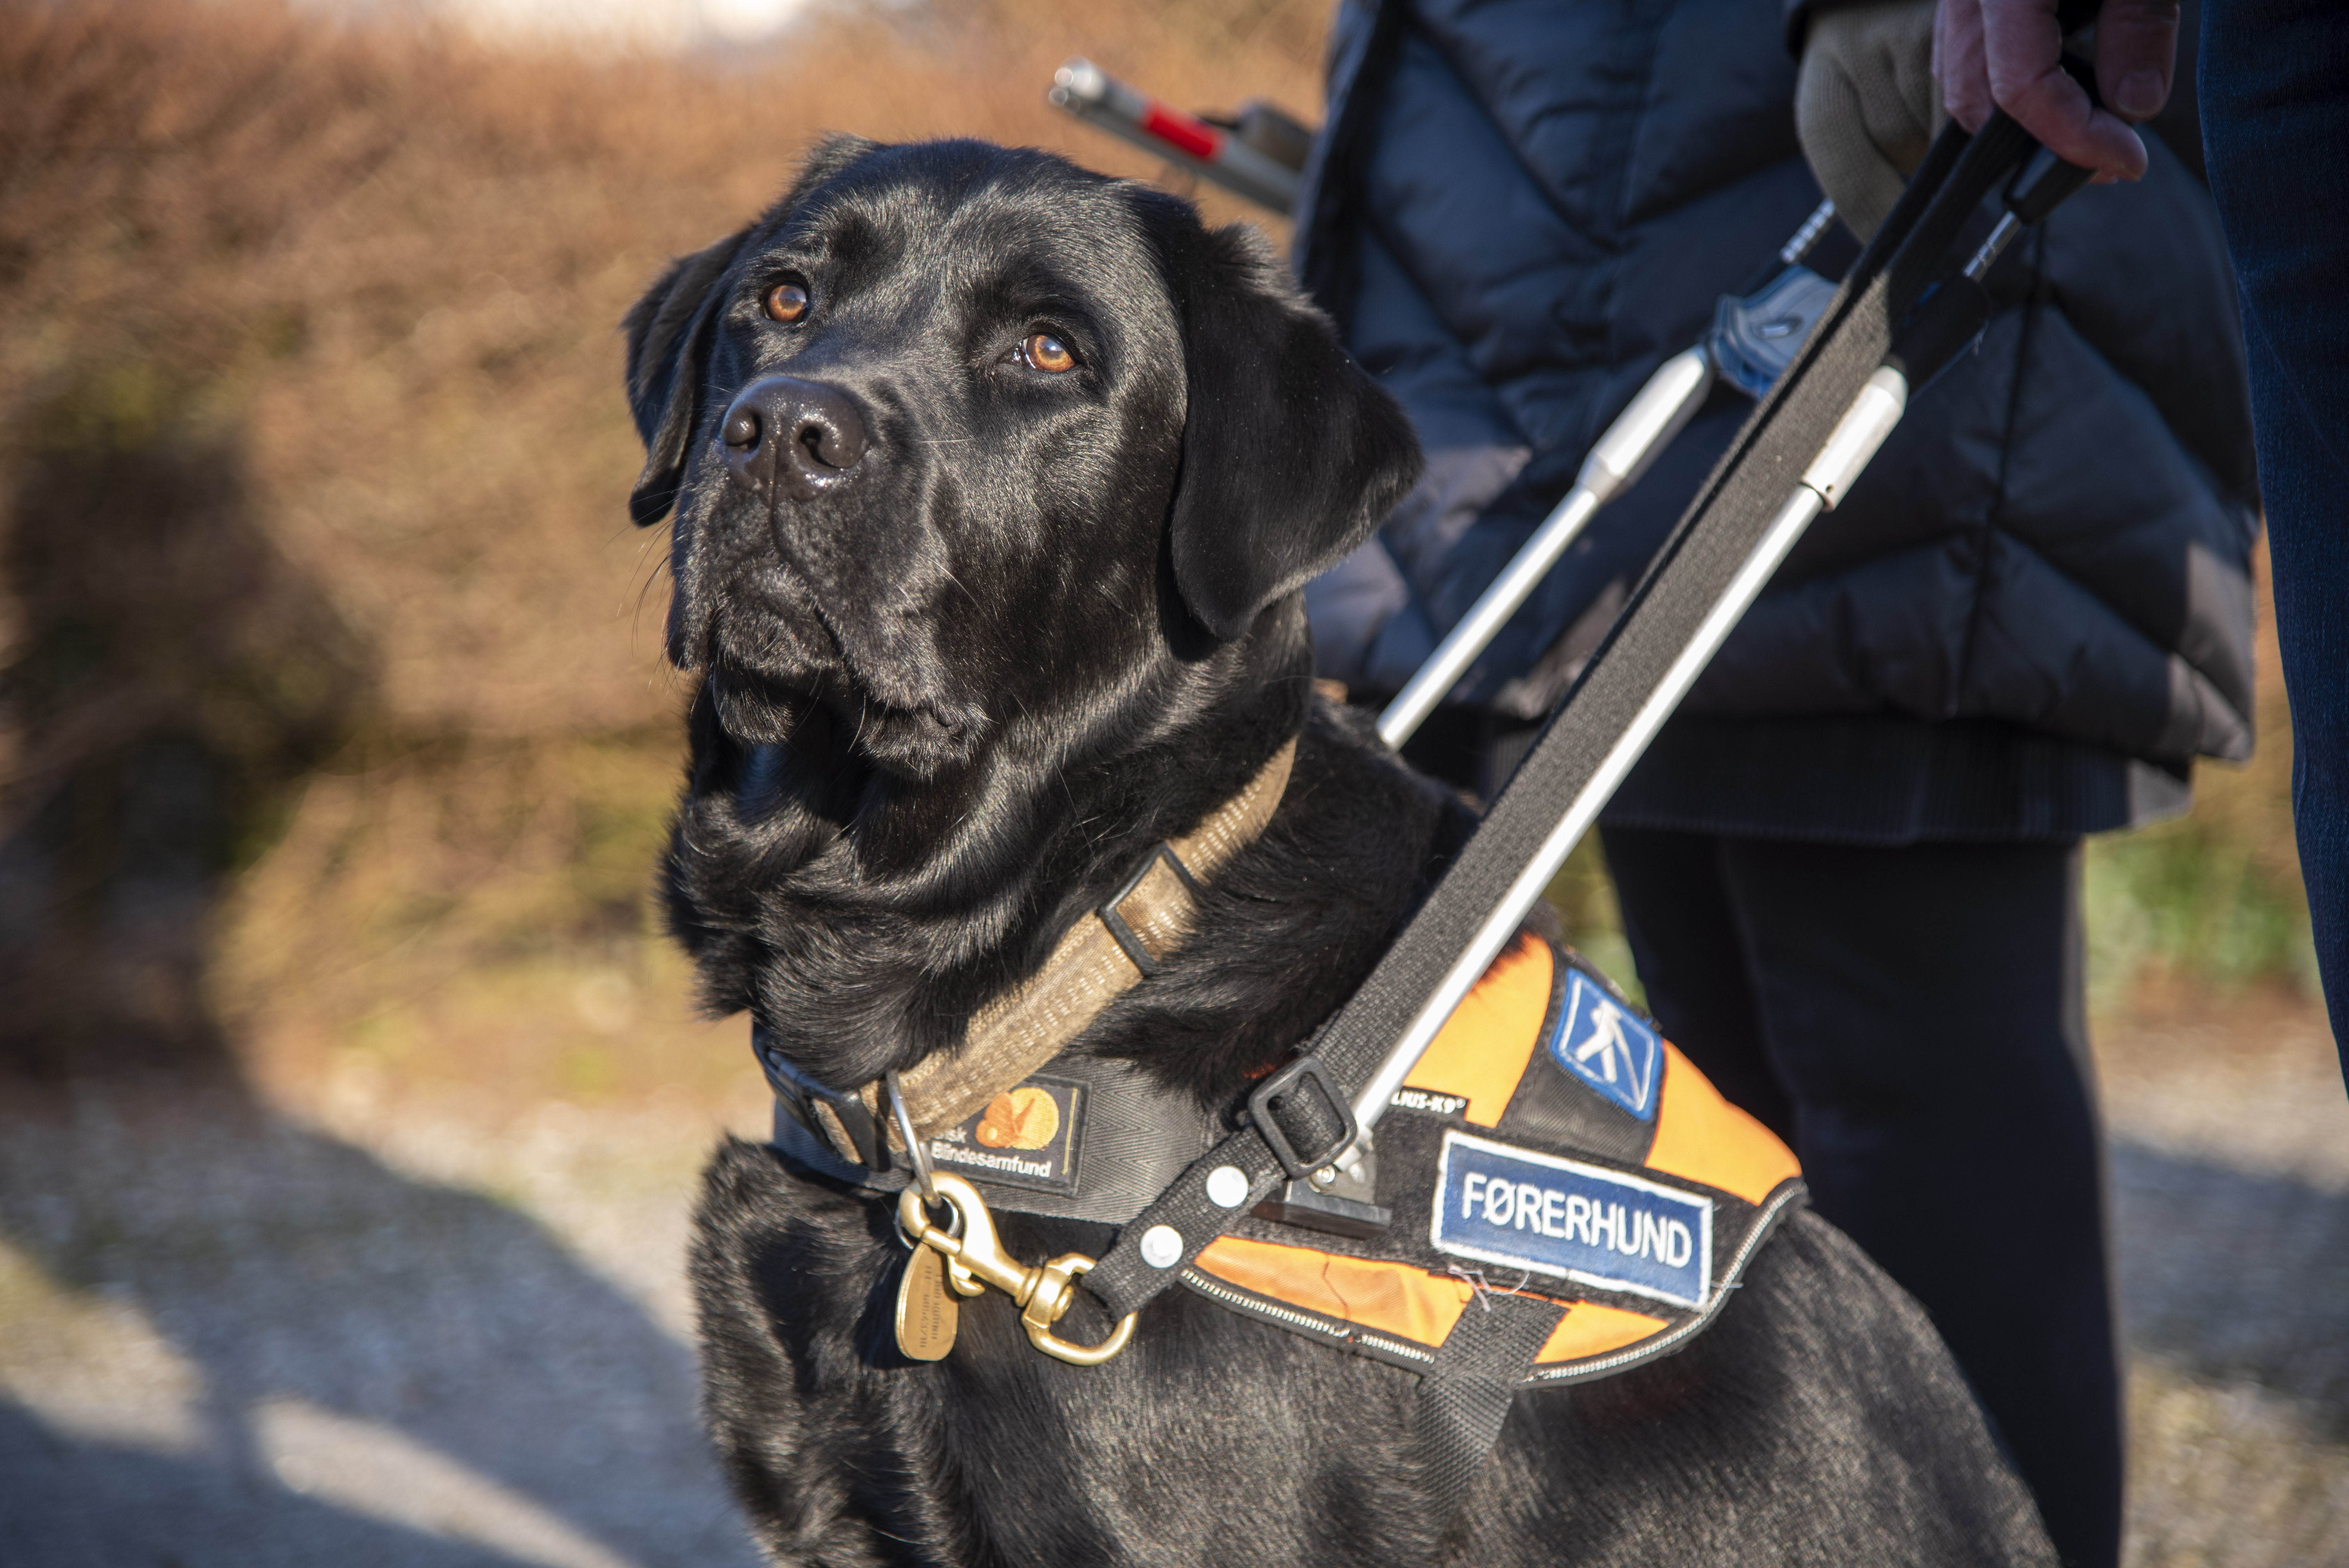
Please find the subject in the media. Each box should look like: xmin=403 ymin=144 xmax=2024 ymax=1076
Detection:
xmin=0 ymin=1082 xmax=749 ymax=1568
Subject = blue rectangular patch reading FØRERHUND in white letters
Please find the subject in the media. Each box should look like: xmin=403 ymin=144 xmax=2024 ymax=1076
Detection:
xmin=1428 ymin=1131 xmax=1713 ymax=1308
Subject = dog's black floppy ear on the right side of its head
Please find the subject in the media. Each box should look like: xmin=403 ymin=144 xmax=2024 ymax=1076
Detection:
xmin=1137 ymin=192 xmax=1419 ymax=641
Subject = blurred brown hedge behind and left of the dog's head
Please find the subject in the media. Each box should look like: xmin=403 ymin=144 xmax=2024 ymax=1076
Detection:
xmin=0 ymin=0 xmax=1325 ymax=1087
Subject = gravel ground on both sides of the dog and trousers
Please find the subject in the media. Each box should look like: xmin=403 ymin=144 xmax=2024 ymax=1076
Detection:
xmin=0 ymin=1007 xmax=2349 ymax=1568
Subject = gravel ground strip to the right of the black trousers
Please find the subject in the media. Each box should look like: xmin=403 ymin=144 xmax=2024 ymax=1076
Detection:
xmin=2100 ymin=1007 xmax=2349 ymax=1568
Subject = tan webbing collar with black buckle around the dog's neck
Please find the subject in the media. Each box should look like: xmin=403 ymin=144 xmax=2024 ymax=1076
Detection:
xmin=811 ymin=737 xmax=1297 ymax=1162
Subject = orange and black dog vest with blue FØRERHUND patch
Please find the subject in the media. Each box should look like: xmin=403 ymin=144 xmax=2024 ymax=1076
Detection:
xmin=1184 ymin=932 xmax=1804 ymax=1387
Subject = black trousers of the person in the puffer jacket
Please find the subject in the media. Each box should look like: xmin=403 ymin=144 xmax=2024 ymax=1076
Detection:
xmin=1604 ymin=829 xmax=2121 ymax=1568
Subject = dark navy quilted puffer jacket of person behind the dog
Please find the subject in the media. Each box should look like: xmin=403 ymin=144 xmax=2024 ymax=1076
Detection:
xmin=1297 ymin=0 xmax=2257 ymax=843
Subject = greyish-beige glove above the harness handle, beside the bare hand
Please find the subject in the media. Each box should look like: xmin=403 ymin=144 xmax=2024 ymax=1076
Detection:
xmin=1795 ymin=0 xmax=1950 ymax=239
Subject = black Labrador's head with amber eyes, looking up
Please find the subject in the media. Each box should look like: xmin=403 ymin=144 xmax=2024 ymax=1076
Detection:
xmin=627 ymin=139 xmax=1419 ymax=782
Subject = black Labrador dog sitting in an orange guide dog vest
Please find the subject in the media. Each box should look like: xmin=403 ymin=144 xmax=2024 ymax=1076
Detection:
xmin=627 ymin=139 xmax=2051 ymax=1568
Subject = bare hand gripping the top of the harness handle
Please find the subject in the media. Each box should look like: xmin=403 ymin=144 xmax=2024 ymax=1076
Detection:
xmin=1933 ymin=0 xmax=2178 ymax=181
